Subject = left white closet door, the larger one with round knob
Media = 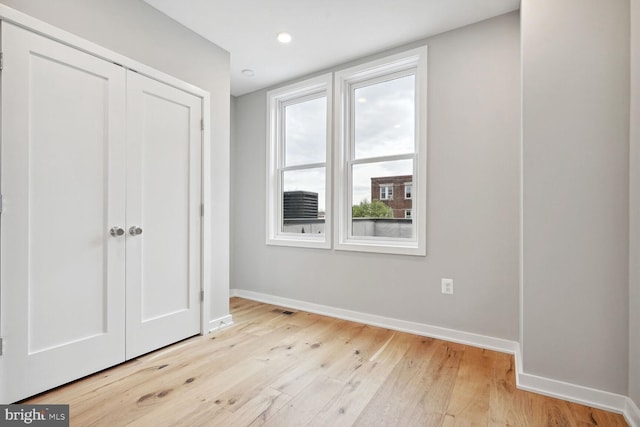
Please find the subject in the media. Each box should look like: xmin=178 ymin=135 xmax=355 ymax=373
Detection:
xmin=0 ymin=23 xmax=125 ymax=402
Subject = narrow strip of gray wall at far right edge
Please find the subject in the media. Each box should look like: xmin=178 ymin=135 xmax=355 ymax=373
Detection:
xmin=629 ymin=0 xmax=640 ymax=407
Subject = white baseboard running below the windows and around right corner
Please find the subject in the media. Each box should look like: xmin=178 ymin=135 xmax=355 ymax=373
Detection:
xmin=230 ymin=289 xmax=640 ymax=427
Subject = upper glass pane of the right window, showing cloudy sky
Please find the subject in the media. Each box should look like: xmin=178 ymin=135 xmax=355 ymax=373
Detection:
xmin=354 ymin=75 xmax=415 ymax=159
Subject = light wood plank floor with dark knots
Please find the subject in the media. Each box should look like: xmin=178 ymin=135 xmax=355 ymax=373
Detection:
xmin=23 ymin=298 xmax=627 ymax=427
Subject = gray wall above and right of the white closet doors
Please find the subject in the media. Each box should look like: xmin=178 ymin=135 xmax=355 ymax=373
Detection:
xmin=0 ymin=0 xmax=230 ymax=318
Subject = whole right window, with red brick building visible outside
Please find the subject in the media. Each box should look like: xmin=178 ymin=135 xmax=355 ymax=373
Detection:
xmin=335 ymin=47 xmax=426 ymax=255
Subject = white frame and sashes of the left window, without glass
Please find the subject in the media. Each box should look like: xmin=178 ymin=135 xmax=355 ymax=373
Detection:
xmin=266 ymin=74 xmax=333 ymax=249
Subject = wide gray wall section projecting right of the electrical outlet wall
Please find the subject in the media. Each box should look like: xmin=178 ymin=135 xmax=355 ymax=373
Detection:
xmin=521 ymin=0 xmax=630 ymax=395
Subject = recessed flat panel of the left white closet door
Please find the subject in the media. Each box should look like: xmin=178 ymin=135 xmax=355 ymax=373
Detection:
xmin=28 ymin=56 xmax=108 ymax=352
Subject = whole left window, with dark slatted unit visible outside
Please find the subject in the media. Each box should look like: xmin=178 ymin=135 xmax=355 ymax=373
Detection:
xmin=267 ymin=75 xmax=332 ymax=248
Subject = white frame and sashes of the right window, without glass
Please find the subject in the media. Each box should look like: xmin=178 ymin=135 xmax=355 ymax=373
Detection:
xmin=334 ymin=46 xmax=427 ymax=256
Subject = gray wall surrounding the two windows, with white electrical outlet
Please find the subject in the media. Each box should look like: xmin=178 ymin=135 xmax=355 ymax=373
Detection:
xmin=231 ymin=12 xmax=520 ymax=339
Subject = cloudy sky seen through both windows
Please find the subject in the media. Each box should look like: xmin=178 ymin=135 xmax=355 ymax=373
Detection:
xmin=283 ymin=75 xmax=415 ymax=211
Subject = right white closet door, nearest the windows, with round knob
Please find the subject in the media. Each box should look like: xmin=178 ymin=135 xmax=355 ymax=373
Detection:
xmin=126 ymin=72 xmax=202 ymax=359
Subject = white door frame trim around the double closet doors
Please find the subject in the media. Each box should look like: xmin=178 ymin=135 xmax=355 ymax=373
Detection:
xmin=0 ymin=4 xmax=213 ymax=392
